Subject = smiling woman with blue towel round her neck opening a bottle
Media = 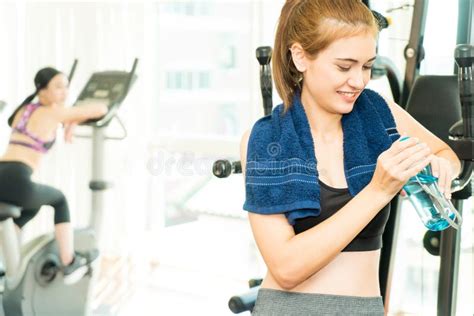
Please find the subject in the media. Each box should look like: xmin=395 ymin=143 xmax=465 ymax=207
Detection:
xmin=241 ymin=0 xmax=460 ymax=316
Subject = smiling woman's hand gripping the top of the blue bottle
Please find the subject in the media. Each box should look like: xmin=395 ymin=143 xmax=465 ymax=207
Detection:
xmin=369 ymin=138 xmax=432 ymax=196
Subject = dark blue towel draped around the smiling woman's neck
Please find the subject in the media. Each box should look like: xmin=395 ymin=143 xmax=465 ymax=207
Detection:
xmin=243 ymin=89 xmax=400 ymax=225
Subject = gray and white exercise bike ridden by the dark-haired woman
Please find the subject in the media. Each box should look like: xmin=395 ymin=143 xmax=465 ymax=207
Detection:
xmin=0 ymin=59 xmax=138 ymax=316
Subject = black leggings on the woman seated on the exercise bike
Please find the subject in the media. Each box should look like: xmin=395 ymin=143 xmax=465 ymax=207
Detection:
xmin=0 ymin=161 xmax=70 ymax=228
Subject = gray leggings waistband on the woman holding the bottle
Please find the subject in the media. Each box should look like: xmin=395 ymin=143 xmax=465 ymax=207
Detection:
xmin=252 ymin=288 xmax=384 ymax=316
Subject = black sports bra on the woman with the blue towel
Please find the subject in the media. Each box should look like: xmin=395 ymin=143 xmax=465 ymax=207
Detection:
xmin=293 ymin=181 xmax=390 ymax=251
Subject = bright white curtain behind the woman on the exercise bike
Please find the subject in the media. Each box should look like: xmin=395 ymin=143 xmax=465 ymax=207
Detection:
xmin=0 ymin=1 xmax=160 ymax=251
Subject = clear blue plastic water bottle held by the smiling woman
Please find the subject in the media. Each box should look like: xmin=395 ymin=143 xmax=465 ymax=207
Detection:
xmin=400 ymin=137 xmax=462 ymax=231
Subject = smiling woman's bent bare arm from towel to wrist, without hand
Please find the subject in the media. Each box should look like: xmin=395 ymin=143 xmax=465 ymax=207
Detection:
xmin=249 ymin=188 xmax=391 ymax=289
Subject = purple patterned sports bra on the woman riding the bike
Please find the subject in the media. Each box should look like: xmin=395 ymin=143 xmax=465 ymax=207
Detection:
xmin=10 ymin=103 xmax=56 ymax=153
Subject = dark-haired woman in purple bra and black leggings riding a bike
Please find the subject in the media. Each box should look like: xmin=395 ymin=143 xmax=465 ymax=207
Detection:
xmin=0 ymin=67 xmax=107 ymax=284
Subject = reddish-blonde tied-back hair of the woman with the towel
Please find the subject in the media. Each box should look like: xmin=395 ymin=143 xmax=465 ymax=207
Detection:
xmin=272 ymin=0 xmax=379 ymax=111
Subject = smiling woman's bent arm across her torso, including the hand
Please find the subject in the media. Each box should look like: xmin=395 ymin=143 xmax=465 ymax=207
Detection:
xmin=241 ymin=128 xmax=430 ymax=289
